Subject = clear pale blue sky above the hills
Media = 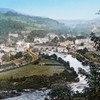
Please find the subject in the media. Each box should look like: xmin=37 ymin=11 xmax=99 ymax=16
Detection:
xmin=0 ymin=0 xmax=100 ymax=20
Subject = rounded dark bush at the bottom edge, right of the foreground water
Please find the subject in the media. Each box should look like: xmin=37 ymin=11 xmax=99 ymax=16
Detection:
xmin=49 ymin=83 xmax=71 ymax=100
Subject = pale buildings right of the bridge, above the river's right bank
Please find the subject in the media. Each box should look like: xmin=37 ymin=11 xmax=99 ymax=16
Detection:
xmin=57 ymin=38 xmax=95 ymax=52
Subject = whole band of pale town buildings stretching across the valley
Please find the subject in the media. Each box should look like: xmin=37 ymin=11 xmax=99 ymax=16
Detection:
xmin=0 ymin=33 xmax=95 ymax=65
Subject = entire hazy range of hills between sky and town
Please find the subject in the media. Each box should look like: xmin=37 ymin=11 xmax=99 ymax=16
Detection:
xmin=0 ymin=8 xmax=100 ymax=36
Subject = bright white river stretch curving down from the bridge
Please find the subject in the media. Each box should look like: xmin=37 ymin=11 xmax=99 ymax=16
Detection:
xmin=47 ymin=52 xmax=90 ymax=93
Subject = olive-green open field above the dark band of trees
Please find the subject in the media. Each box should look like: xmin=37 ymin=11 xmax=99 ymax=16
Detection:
xmin=0 ymin=64 xmax=64 ymax=79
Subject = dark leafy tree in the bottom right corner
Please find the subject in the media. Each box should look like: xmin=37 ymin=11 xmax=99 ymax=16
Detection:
xmin=83 ymin=62 xmax=100 ymax=100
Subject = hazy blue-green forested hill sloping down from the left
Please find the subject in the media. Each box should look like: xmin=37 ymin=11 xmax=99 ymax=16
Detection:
xmin=0 ymin=8 xmax=67 ymax=35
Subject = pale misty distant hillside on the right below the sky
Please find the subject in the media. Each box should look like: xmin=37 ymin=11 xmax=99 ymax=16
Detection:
xmin=58 ymin=19 xmax=100 ymax=36
